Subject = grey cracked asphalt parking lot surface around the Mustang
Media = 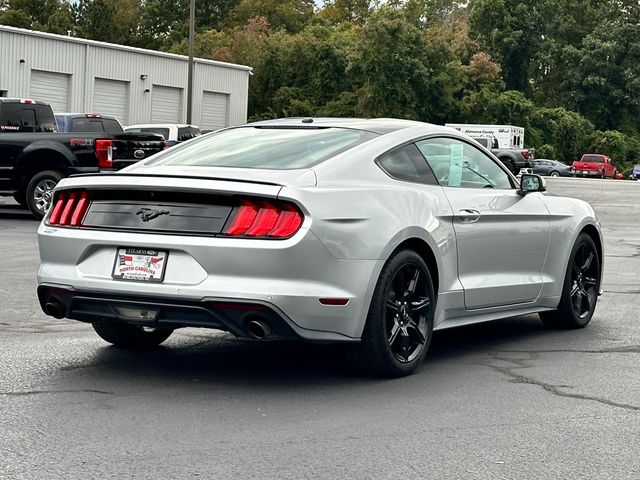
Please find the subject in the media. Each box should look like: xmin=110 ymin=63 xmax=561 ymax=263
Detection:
xmin=0 ymin=178 xmax=640 ymax=480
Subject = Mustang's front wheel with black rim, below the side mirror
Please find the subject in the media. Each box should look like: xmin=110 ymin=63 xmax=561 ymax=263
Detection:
xmin=539 ymin=233 xmax=600 ymax=329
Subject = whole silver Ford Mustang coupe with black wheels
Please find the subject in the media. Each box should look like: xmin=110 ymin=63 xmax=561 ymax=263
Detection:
xmin=38 ymin=118 xmax=604 ymax=376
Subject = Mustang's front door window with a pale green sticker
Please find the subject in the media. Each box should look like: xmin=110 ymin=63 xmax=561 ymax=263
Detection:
xmin=416 ymin=138 xmax=513 ymax=188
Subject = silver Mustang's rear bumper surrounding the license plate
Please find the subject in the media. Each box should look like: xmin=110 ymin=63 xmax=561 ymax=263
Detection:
xmin=38 ymin=223 xmax=384 ymax=341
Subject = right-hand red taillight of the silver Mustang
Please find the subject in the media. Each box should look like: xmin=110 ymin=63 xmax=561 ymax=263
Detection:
xmin=222 ymin=200 xmax=303 ymax=238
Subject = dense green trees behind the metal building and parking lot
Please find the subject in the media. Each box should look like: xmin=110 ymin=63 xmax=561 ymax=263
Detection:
xmin=0 ymin=0 xmax=640 ymax=169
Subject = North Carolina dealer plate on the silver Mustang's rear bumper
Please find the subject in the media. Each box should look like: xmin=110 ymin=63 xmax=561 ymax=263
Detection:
xmin=111 ymin=247 xmax=169 ymax=282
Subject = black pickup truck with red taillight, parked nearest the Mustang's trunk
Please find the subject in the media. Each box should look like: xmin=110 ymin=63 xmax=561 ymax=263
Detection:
xmin=0 ymin=98 xmax=166 ymax=218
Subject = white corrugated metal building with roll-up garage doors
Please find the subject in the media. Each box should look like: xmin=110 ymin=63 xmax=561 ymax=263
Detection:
xmin=0 ymin=25 xmax=251 ymax=130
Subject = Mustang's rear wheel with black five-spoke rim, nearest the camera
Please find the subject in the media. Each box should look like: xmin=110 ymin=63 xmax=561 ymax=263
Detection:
xmin=362 ymin=250 xmax=435 ymax=377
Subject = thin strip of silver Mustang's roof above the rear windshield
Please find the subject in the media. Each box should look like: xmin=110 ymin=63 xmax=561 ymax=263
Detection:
xmin=248 ymin=117 xmax=442 ymax=134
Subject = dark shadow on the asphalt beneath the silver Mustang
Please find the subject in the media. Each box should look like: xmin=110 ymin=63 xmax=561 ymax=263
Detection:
xmin=57 ymin=315 xmax=561 ymax=387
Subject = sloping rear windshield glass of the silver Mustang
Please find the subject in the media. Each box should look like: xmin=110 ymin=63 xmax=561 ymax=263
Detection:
xmin=151 ymin=127 xmax=377 ymax=170
